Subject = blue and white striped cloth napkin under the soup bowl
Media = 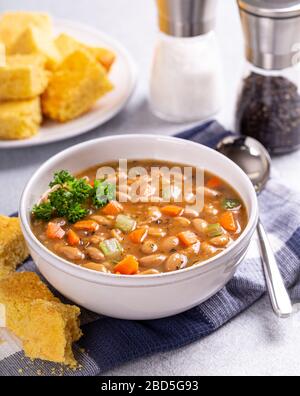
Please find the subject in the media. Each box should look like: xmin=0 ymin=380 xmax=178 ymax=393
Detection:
xmin=0 ymin=122 xmax=300 ymax=376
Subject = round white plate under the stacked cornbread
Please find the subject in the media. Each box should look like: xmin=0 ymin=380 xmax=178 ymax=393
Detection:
xmin=0 ymin=19 xmax=137 ymax=149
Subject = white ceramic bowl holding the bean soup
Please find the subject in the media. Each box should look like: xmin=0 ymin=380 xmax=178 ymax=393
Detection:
xmin=20 ymin=135 xmax=258 ymax=320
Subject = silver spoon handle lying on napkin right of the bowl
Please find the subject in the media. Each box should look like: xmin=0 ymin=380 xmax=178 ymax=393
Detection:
xmin=257 ymin=221 xmax=293 ymax=318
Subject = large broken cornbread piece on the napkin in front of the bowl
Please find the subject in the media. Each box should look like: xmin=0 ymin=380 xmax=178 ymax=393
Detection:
xmin=0 ymin=272 xmax=82 ymax=366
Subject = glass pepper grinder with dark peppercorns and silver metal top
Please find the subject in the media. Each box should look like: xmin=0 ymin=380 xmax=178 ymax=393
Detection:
xmin=236 ymin=0 xmax=300 ymax=154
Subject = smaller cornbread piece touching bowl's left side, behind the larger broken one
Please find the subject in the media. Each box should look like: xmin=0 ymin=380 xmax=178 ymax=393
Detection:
xmin=0 ymin=215 xmax=29 ymax=279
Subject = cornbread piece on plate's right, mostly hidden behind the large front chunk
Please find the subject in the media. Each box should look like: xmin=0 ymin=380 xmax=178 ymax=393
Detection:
xmin=55 ymin=33 xmax=116 ymax=72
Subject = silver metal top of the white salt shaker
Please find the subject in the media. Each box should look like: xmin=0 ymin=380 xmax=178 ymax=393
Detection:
xmin=156 ymin=0 xmax=218 ymax=37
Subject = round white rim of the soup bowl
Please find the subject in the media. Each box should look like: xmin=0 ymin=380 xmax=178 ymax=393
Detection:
xmin=19 ymin=134 xmax=258 ymax=284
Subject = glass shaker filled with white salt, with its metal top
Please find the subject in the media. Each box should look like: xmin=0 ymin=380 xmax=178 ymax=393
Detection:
xmin=150 ymin=0 xmax=223 ymax=122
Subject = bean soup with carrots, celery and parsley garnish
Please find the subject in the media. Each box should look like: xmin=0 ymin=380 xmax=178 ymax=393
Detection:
xmin=32 ymin=160 xmax=248 ymax=275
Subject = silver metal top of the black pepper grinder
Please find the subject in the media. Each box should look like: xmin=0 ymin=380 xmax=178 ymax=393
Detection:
xmin=237 ymin=0 xmax=300 ymax=70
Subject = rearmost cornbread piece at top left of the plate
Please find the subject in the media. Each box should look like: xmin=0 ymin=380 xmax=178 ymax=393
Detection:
xmin=0 ymin=11 xmax=52 ymax=54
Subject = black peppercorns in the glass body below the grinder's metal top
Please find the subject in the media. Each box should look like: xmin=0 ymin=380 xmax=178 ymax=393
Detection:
xmin=236 ymin=73 xmax=300 ymax=154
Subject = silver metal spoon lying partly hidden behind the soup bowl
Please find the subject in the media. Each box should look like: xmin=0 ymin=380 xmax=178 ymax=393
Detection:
xmin=217 ymin=136 xmax=293 ymax=318
